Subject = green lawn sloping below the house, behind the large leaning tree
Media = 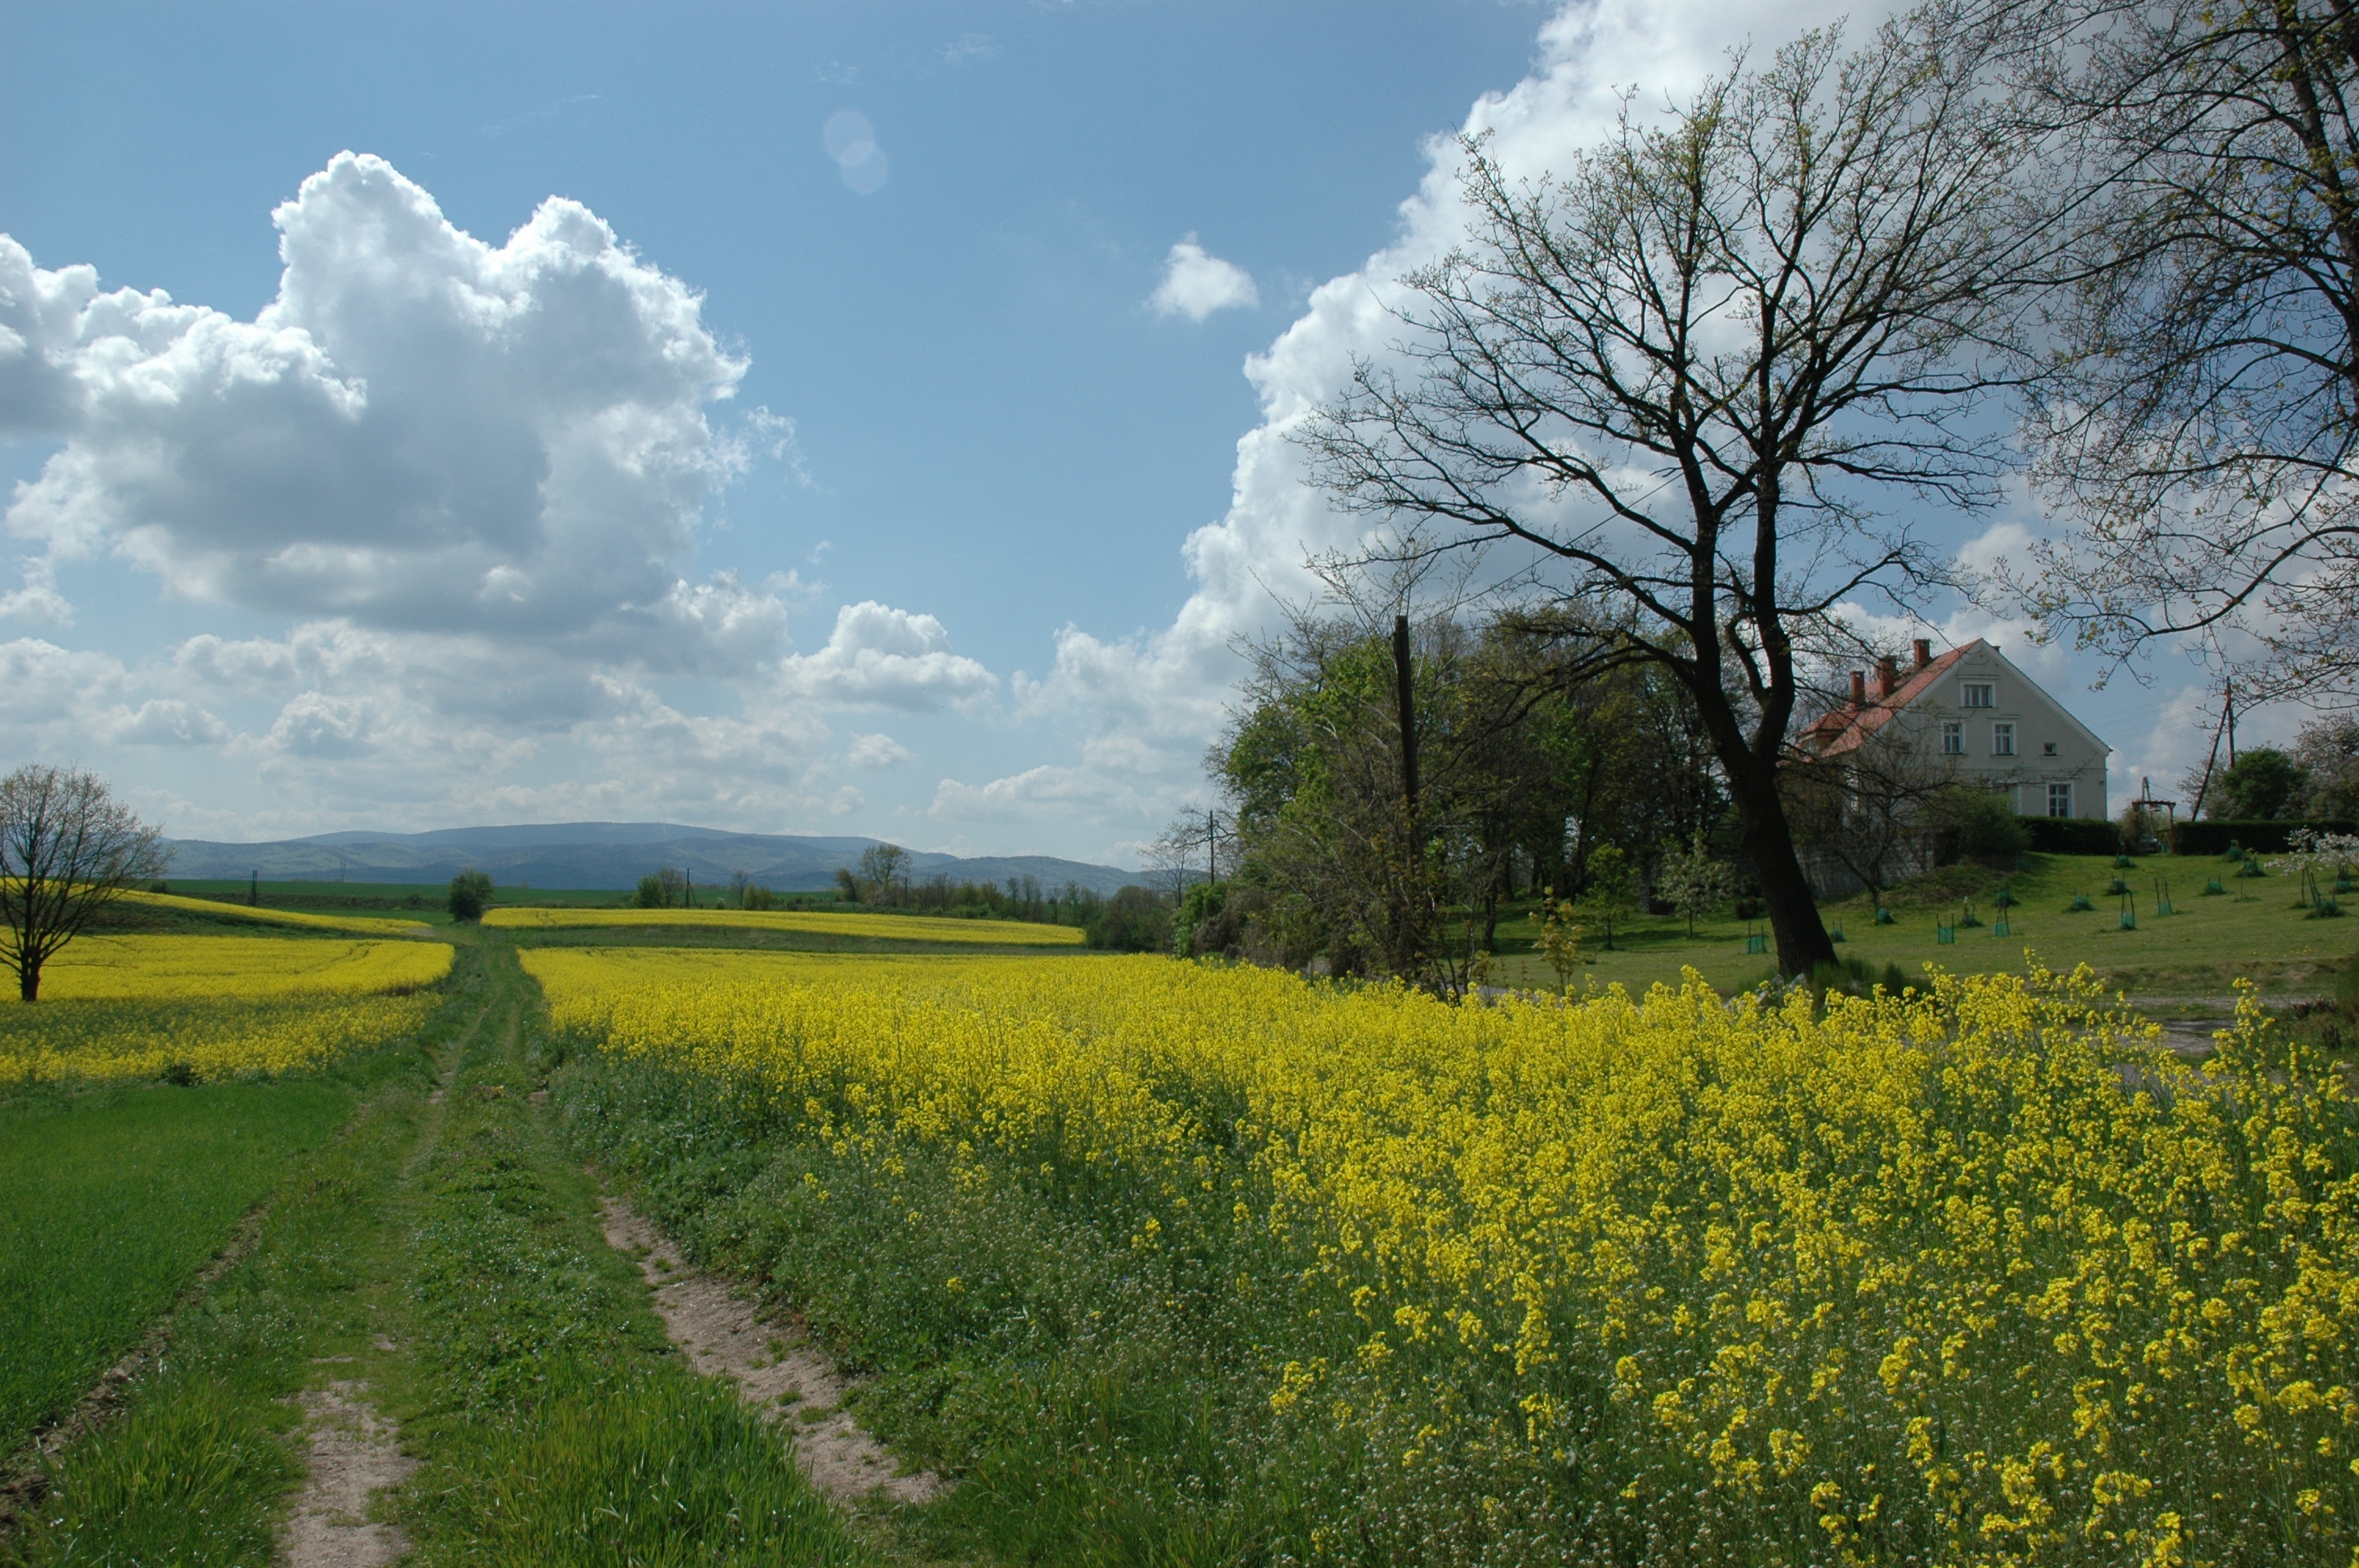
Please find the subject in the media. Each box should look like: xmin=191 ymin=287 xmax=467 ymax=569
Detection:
xmin=1496 ymin=856 xmax=2359 ymax=1007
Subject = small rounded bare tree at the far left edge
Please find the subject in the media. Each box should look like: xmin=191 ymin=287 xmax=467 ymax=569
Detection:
xmin=0 ymin=761 xmax=168 ymax=1002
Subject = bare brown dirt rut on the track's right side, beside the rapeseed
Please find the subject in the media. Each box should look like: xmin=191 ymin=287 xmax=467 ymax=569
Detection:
xmin=604 ymin=1198 xmax=943 ymax=1502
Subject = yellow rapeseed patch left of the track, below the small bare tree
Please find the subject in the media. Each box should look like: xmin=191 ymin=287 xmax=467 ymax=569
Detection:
xmin=0 ymin=936 xmax=451 ymax=1084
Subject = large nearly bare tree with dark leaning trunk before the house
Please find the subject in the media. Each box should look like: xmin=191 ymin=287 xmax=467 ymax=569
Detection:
xmin=1299 ymin=5 xmax=2043 ymax=971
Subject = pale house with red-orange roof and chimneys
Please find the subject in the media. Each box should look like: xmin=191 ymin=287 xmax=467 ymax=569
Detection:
xmin=1802 ymin=637 xmax=2114 ymax=818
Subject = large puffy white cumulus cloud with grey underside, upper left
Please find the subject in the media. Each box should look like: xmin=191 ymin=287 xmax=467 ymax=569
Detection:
xmin=0 ymin=153 xmax=783 ymax=670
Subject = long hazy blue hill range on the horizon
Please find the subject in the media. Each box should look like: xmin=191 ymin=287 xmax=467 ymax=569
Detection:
xmin=165 ymin=823 xmax=1142 ymax=894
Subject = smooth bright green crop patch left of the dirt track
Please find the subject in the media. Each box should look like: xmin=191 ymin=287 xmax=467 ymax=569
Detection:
xmin=0 ymin=1077 xmax=354 ymax=1455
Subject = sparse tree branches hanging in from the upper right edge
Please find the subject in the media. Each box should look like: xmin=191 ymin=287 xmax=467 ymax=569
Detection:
xmin=1994 ymin=0 xmax=2359 ymax=702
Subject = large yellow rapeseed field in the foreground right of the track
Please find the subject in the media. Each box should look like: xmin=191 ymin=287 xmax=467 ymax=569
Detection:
xmin=524 ymin=950 xmax=2359 ymax=1568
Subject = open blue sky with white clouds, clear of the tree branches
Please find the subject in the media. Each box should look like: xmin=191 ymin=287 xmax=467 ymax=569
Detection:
xmin=0 ymin=0 xmax=2274 ymax=863
